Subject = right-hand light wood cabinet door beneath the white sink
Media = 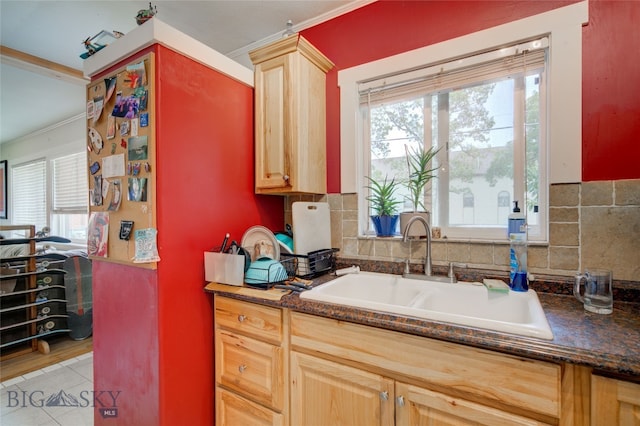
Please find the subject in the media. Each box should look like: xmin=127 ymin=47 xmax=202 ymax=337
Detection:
xmin=396 ymin=382 xmax=545 ymax=426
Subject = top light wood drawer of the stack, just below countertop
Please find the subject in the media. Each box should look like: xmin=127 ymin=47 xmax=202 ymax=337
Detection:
xmin=215 ymin=296 xmax=282 ymax=345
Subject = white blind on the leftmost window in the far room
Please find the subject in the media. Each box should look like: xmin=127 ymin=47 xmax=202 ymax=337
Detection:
xmin=11 ymin=159 xmax=47 ymax=229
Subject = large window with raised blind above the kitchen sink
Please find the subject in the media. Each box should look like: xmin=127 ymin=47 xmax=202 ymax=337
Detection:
xmin=359 ymin=37 xmax=548 ymax=239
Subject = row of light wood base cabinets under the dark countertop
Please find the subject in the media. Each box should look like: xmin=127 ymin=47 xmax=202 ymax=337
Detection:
xmin=215 ymin=295 xmax=640 ymax=426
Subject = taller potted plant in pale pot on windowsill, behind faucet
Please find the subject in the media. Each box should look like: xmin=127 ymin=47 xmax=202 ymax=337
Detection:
xmin=400 ymin=145 xmax=440 ymax=237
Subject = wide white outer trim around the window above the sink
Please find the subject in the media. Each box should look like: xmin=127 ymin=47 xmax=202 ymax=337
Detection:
xmin=338 ymin=1 xmax=588 ymax=243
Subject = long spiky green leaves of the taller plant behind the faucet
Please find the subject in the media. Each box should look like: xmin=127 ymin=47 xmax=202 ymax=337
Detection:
xmin=404 ymin=145 xmax=440 ymax=212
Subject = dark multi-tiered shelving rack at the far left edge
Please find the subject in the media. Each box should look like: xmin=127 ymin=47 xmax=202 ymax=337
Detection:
xmin=0 ymin=225 xmax=69 ymax=360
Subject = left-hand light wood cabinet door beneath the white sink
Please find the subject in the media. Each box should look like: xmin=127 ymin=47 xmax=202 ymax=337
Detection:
xmin=291 ymin=352 xmax=394 ymax=426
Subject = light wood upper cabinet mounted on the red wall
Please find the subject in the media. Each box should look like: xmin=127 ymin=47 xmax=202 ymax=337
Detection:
xmin=249 ymin=34 xmax=333 ymax=195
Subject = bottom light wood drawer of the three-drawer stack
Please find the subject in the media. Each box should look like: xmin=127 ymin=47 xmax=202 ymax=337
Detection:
xmin=216 ymin=387 xmax=284 ymax=426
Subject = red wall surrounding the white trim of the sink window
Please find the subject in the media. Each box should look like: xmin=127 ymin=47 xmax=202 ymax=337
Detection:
xmin=302 ymin=0 xmax=640 ymax=193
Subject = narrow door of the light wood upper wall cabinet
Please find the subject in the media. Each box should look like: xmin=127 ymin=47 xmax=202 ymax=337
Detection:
xmin=255 ymin=55 xmax=295 ymax=188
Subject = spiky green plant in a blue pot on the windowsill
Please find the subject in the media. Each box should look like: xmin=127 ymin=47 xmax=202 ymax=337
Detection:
xmin=367 ymin=176 xmax=401 ymax=237
